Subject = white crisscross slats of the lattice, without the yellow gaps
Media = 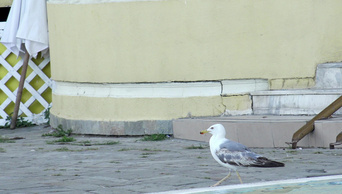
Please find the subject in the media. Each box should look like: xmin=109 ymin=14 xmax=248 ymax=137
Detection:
xmin=0 ymin=23 xmax=52 ymax=126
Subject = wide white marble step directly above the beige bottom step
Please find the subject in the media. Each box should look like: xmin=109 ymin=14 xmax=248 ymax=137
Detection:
xmin=251 ymin=89 xmax=342 ymax=115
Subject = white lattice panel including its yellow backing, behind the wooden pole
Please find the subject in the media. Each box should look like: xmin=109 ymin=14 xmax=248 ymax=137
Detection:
xmin=0 ymin=44 xmax=52 ymax=126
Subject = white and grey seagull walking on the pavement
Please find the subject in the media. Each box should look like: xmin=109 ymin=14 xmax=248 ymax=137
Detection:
xmin=200 ymin=124 xmax=285 ymax=187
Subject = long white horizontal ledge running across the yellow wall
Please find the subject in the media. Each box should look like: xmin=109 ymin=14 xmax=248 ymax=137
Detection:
xmin=53 ymin=81 xmax=221 ymax=98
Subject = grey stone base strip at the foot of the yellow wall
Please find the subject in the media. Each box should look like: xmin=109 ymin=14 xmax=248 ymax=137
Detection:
xmin=50 ymin=114 xmax=173 ymax=136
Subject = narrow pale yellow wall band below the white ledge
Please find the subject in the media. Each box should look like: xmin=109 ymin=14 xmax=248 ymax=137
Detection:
xmin=52 ymin=95 xmax=225 ymax=121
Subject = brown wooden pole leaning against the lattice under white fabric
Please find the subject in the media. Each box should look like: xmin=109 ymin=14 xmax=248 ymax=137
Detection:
xmin=10 ymin=49 xmax=30 ymax=129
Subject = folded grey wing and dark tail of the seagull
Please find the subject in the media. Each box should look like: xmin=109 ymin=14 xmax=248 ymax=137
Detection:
xmin=216 ymin=140 xmax=284 ymax=167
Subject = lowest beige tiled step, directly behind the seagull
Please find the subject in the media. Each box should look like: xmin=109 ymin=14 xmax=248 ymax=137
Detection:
xmin=173 ymin=115 xmax=342 ymax=148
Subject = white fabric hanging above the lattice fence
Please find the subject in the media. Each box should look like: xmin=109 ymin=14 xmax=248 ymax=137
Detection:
xmin=1 ymin=0 xmax=49 ymax=58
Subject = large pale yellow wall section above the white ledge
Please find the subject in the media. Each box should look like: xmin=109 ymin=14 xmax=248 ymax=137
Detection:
xmin=48 ymin=0 xmax=342 ymax=83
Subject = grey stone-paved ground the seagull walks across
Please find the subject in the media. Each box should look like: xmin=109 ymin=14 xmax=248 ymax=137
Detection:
xmin=0 ymin=126 xmax=342 ymax=193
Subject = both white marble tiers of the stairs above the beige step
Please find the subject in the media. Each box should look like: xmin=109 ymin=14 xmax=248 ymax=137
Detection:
xmin=251 ymin=63 xmax=342 ymax=115
